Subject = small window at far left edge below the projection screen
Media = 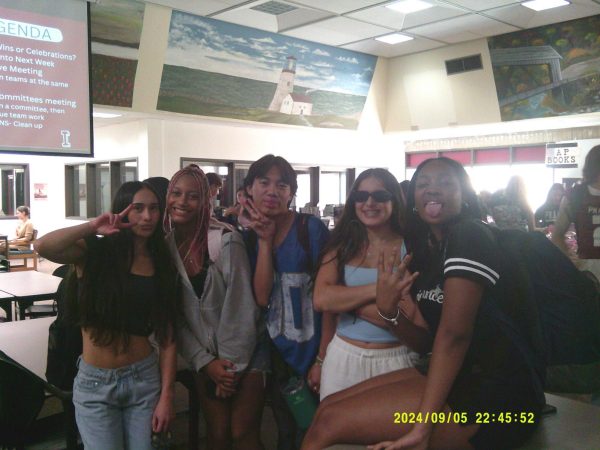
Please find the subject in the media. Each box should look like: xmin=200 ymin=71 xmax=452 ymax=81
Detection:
xmin=0 ymin=164 xmax=29 ymax=219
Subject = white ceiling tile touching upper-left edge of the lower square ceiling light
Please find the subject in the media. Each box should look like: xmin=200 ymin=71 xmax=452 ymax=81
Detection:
xmin=282 ymin=17 xmax=391 ymax=45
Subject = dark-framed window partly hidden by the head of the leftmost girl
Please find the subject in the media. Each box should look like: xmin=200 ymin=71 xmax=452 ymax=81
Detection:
xmin=65 ymin=160 xmax=138 ymax=218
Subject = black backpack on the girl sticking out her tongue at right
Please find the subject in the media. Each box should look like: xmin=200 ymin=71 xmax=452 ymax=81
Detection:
xmin=488 ymin=227 xmax=600 ymax=392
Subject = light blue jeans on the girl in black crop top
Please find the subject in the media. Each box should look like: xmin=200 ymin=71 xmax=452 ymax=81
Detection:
xmin=73 ymin=353 xmax=161 ymax=450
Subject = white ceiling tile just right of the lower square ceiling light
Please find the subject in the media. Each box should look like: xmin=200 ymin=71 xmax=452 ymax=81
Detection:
xmin=408 ymin=14 xmax=519 ymax=44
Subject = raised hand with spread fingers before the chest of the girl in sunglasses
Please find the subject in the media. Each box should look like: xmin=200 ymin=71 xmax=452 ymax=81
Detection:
xmin=375 ymin=248 xmax=419 ymax=317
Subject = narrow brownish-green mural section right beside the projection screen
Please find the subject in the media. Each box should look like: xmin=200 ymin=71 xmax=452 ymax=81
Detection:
xmin=90 ymin=0 xmax=145 ymax=107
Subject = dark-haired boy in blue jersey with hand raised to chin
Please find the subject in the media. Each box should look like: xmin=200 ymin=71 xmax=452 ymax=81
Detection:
xmin=243 ymin=155 xmax=335 ymax=450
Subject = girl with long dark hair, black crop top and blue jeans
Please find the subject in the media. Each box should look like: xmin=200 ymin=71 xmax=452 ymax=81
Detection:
xmin=35 ymin=181 xmax=176 ymax=450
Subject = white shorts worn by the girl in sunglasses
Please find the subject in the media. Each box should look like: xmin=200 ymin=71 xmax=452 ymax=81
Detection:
xmin=320 ymin=335 xmax=419 ymax=400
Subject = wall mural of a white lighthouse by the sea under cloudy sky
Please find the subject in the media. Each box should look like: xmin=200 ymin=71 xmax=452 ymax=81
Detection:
xmin=157 ymin=11 xmax=377 ymax=129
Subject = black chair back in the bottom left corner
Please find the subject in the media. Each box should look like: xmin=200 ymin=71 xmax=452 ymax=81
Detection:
xmin=0 ymin=351 xmax=45 ymax=449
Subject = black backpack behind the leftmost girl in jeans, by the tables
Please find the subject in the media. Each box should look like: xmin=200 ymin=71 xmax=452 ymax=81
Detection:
xmin=46 ymin=269 xmax=83 ymax=391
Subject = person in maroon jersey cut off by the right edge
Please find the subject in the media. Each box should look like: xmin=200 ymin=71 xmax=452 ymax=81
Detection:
xmin=552 ymin=145 xmax=600 ymax=281
